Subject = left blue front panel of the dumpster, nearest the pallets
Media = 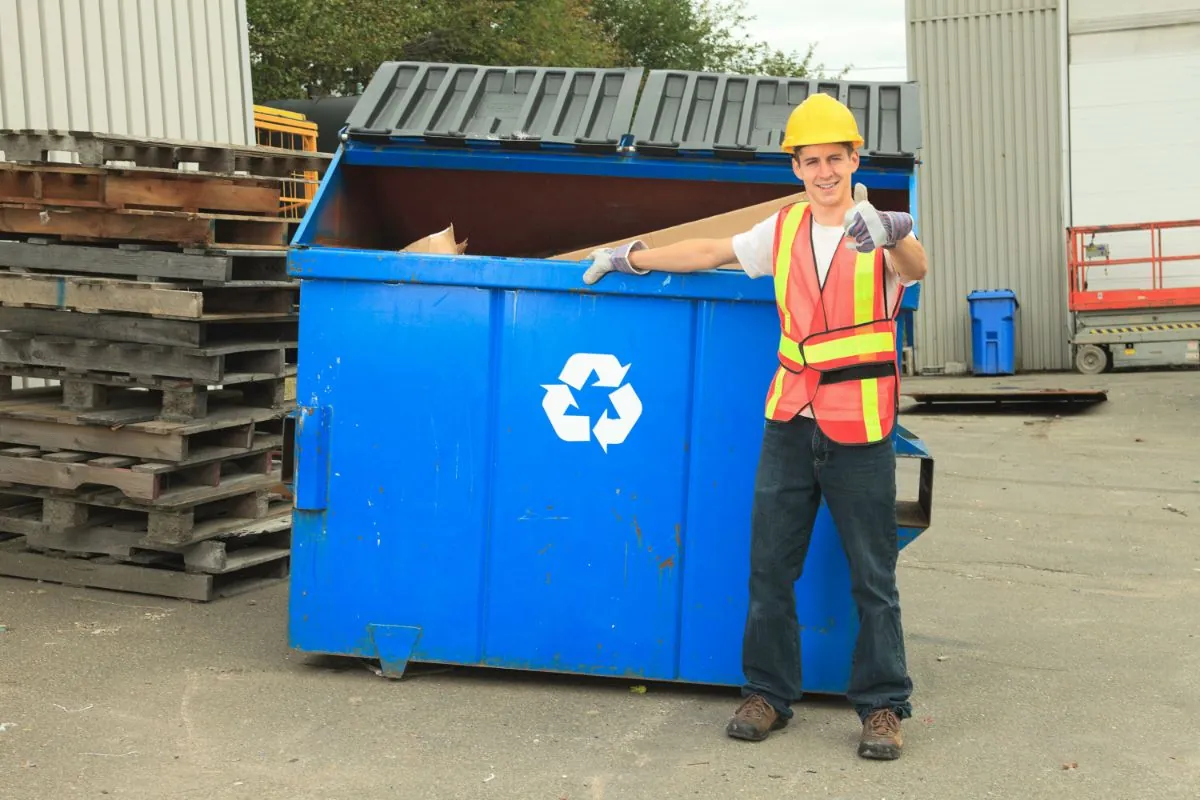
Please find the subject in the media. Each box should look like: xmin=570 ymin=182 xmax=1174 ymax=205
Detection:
xmin=292 ymin=281 xmax=493 ymax=661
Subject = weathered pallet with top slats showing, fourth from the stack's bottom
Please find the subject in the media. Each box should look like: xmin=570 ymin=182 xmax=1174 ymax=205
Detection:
xmin=0 ymin=433 xmax=282 ymax=501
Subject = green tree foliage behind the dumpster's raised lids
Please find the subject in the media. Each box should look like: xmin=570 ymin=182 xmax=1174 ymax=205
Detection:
xmin=246 ymin=0 xmax=844 ymax=101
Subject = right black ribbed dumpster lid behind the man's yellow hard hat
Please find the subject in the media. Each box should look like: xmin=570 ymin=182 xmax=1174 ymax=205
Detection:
xmin=632 ymin=70 xmax=922 ymax=164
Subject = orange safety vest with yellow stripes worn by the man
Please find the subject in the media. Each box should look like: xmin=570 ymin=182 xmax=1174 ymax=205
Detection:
xmin=767 ymin=203 xmax=904 ymax=445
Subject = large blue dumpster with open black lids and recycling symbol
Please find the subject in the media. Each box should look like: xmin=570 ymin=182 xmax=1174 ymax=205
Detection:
xmin=287 ymin=64 xmax=932 ymax=693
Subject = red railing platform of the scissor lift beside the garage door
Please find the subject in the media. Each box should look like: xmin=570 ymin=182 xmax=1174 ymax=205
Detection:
xmin=1067 ymin=219 xmax=1200 ymax=311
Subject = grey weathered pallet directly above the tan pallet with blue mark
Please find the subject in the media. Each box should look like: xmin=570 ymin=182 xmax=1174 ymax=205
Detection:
xmin=0 ymin=237 xmax=290 ymax=284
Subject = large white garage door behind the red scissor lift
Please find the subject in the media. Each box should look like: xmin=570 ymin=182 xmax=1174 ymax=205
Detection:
xmin=1068 ymin=6 xmax=1200 ymax=289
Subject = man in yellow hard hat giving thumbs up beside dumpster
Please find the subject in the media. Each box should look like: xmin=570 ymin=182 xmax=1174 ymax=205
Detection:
xmin=583 ymin=94 xmax=926 ymax=759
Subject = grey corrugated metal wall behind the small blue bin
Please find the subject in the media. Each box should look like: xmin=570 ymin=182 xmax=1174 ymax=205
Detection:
xmin=907 ymin=0 xmax=1070 ymax=372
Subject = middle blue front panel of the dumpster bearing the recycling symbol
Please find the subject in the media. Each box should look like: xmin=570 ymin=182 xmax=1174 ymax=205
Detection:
xmin=486 ymin=290 xmax=695 ymax=679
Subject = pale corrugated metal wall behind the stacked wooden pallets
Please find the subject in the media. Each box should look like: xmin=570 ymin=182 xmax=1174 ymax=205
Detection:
xmin=0 ymin=0 xmax=254 ymax=144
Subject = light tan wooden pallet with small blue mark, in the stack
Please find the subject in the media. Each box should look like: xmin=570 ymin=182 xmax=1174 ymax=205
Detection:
xmin=0 ymin=271 xmax=300 ymax=319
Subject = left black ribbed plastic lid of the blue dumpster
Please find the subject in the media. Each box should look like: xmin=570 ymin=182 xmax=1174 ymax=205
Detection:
xmin=346 ymin=61 xmax=644 ymax=150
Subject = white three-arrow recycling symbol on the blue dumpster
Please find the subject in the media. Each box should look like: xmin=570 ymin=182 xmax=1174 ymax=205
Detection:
xmin=541 ymin=353 xmax=642 ymax=452
